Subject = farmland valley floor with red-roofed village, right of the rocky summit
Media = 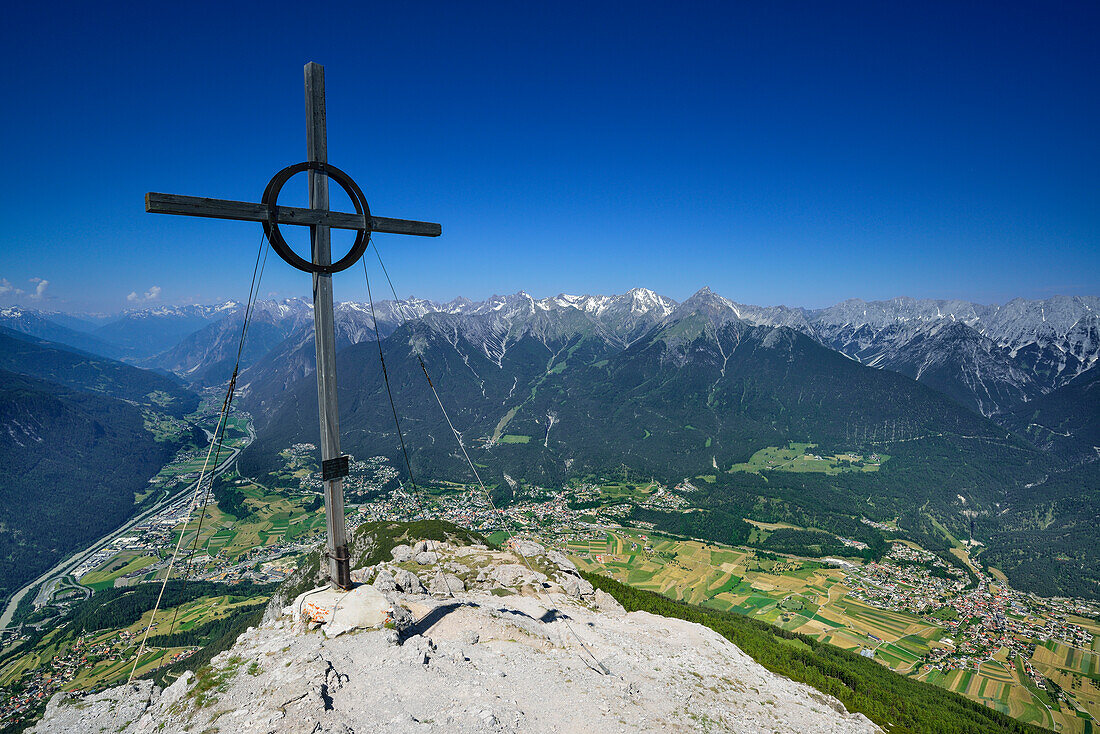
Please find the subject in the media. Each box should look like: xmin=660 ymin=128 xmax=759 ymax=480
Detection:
xmin=560 ymin=528 xmax=1100 ymax=732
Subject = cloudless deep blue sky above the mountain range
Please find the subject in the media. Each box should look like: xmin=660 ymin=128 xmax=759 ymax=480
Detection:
xmin=0 ymin=1 xmax=1100 ymax=310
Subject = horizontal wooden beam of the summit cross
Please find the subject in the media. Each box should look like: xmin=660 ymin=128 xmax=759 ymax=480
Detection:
xmin=145 ymin=191 xmax=443 ymax=237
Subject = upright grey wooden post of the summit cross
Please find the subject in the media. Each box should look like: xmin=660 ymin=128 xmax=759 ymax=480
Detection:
xmin=305 ymin=62 xmax=351 ymax=589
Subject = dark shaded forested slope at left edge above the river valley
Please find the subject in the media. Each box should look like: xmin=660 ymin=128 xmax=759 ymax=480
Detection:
xmin=0 ymin=370 xmax=182 ymax=598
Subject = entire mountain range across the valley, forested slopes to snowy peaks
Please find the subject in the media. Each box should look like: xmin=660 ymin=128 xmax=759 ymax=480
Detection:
xmin=0 ymin=288 xmax=1100 ymax=595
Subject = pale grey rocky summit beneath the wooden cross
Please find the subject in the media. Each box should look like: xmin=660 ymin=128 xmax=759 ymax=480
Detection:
xmin=32 ymin=541 xmax=879 ymax=734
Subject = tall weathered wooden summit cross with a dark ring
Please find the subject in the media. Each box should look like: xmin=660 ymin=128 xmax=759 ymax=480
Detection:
xmin=145 ymin=62 xmax=442 ymax=589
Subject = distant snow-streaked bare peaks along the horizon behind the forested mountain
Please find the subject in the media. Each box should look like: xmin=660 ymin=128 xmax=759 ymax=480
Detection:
xmin=0 ymin=288 xmax=1100 ymax=416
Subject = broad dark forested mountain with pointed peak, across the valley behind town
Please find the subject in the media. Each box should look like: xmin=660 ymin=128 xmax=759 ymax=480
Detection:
xmin=246 ymin=304 xmax=1045 ymax=521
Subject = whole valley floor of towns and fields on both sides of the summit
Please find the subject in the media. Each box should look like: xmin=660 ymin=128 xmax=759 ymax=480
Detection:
xmin=0 ymin=431 xmax=1100 ymax=732
